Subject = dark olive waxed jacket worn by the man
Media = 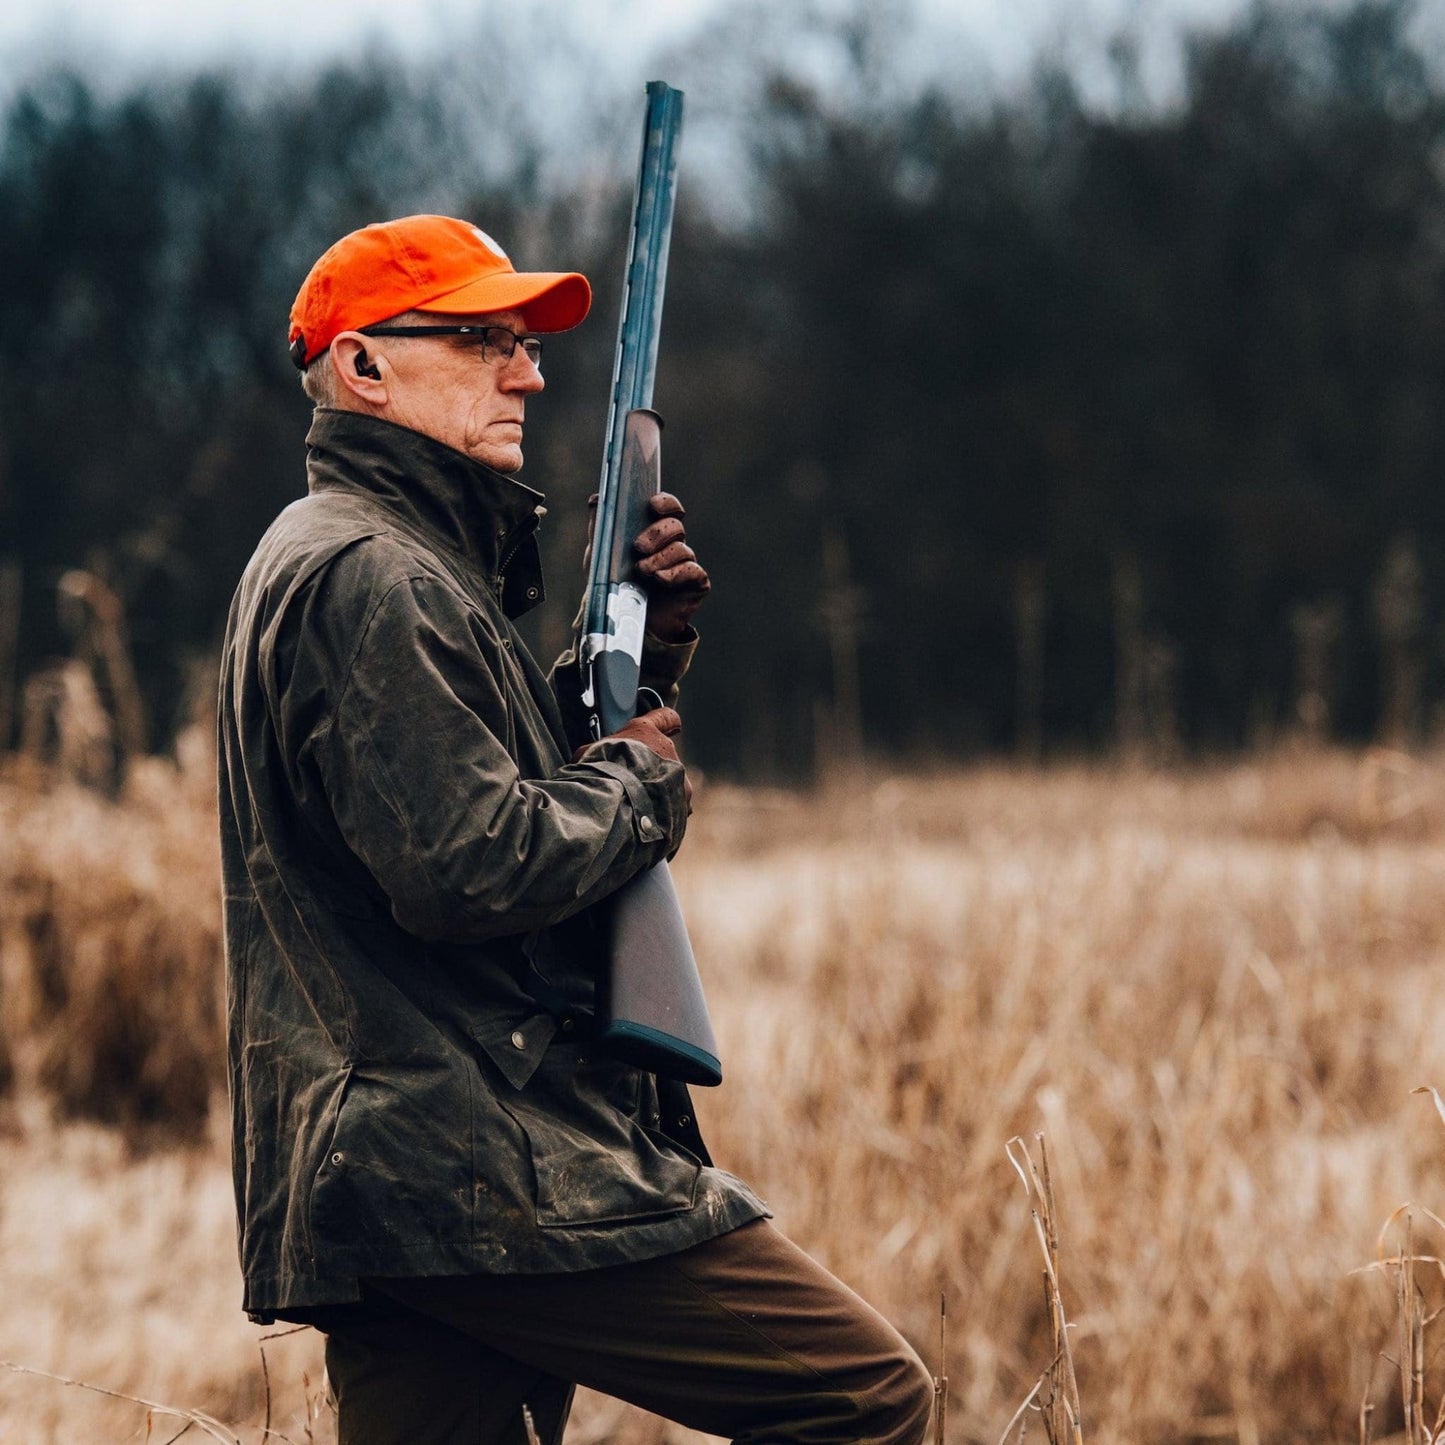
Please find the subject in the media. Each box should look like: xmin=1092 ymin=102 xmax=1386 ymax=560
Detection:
xmin=220 ymin=410 xmax=766 ymax=1318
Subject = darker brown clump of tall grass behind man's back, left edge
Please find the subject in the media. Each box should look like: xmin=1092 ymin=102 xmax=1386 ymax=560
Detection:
xmin=0 ymin=733 xmax=224 ymax=1140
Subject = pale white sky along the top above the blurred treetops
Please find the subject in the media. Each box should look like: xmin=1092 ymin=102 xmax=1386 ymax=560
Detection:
xmin=0 ymin=0 xmax=1445 ymax=126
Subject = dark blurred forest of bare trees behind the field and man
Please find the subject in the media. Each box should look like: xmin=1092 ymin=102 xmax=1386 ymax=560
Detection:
xmin=0 ymin=0 xmax=1445 ymax=779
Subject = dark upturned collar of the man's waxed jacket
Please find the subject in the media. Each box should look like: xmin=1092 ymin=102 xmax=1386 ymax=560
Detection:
xmin=306 ymin=407 xmax=546 ymax=617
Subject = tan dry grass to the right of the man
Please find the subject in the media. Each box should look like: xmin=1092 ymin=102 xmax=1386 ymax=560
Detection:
xmin=678 ymin=757 xmax=1445 ymax=1441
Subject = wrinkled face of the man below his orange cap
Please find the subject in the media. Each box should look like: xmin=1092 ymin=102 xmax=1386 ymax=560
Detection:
xmin=374 ymin=311 xmax=545 ymax=473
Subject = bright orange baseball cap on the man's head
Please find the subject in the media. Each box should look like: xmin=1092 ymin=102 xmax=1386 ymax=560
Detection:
xmin=289 ymin=215 xmax=592 ymax=370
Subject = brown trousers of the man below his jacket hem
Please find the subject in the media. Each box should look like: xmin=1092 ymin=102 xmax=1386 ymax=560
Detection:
xmin=327 ymin=1220 xmax=933 ymax=1445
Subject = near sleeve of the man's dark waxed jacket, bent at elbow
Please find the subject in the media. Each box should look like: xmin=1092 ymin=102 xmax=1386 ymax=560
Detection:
xmin=312 ymin=578 xmax=686 ymax=942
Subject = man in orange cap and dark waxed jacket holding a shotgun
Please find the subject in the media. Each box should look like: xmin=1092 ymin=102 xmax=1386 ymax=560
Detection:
xmin=220 ymin=217 xmax=931 ymax=1445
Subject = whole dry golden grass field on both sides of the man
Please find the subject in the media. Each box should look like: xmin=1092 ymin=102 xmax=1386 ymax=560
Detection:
xmin=0 ymin=746 xmax=1445 ymax=1445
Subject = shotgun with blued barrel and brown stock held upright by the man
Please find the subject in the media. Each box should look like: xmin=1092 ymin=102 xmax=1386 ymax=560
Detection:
xmin=581 ymin=81 xmax=723 ymax=1084
